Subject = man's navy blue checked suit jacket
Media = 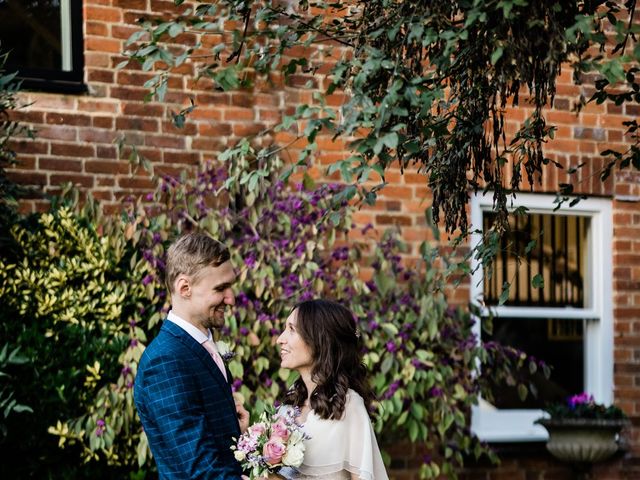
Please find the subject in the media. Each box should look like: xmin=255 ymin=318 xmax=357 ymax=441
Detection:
xmin=134 ymin=320 xmax=242 ymax=480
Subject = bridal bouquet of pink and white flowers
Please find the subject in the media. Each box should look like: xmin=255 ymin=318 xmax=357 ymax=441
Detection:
xmin=231 ymin=408 xmax=310 ymax=479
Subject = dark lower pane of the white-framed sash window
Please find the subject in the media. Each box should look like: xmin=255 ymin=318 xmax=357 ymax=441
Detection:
xmin=482 ymin=318 xmax=584 ymax=409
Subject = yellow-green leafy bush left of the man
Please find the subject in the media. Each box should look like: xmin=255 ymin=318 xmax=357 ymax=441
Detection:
xmin=0 ymin=195 xmax=156 ymax=478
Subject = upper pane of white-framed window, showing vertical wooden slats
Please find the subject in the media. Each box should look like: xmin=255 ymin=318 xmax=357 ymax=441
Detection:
xmin=483 ymin=212 xmax=590 ymax=308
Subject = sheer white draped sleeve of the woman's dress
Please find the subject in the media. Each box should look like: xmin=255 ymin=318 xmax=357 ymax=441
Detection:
xmin=342 ymin=391 xmax=389 ymax=480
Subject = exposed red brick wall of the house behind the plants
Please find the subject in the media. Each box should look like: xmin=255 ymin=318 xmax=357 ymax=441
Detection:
xmin=6 ymin=0 xmax=640 ymax=480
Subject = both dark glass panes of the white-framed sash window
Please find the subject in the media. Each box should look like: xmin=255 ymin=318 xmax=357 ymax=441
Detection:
xmin=482 ymin=212 xmax=591 ymax=409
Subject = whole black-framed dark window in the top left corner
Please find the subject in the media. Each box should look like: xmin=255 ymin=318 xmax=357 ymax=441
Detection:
xmin=0 ymin=0 xmax=84 ymax=92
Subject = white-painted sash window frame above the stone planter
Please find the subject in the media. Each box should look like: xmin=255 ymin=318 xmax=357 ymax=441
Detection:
xmin=470 ymin=193 xmax=613 ymax=442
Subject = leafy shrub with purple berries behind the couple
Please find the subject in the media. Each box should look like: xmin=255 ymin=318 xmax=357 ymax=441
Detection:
xmin=46 ymin=145 xmax=531 ymax=477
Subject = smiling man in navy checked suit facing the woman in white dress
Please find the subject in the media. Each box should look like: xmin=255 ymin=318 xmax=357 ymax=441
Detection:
xmin=134 ymin=233 xmax=249 ymax=480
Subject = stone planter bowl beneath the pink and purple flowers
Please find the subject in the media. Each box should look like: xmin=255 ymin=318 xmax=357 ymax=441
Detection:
xmin=537 ymin=418 xmax=626 ymax=464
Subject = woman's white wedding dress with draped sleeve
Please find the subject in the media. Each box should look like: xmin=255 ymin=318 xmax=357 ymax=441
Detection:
xmin=278 ymin=389 xmax=389 ymax=480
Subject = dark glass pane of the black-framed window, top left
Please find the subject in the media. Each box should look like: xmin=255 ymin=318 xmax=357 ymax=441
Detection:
xmin=0 ymin=0 xmax=71 ymax=71
